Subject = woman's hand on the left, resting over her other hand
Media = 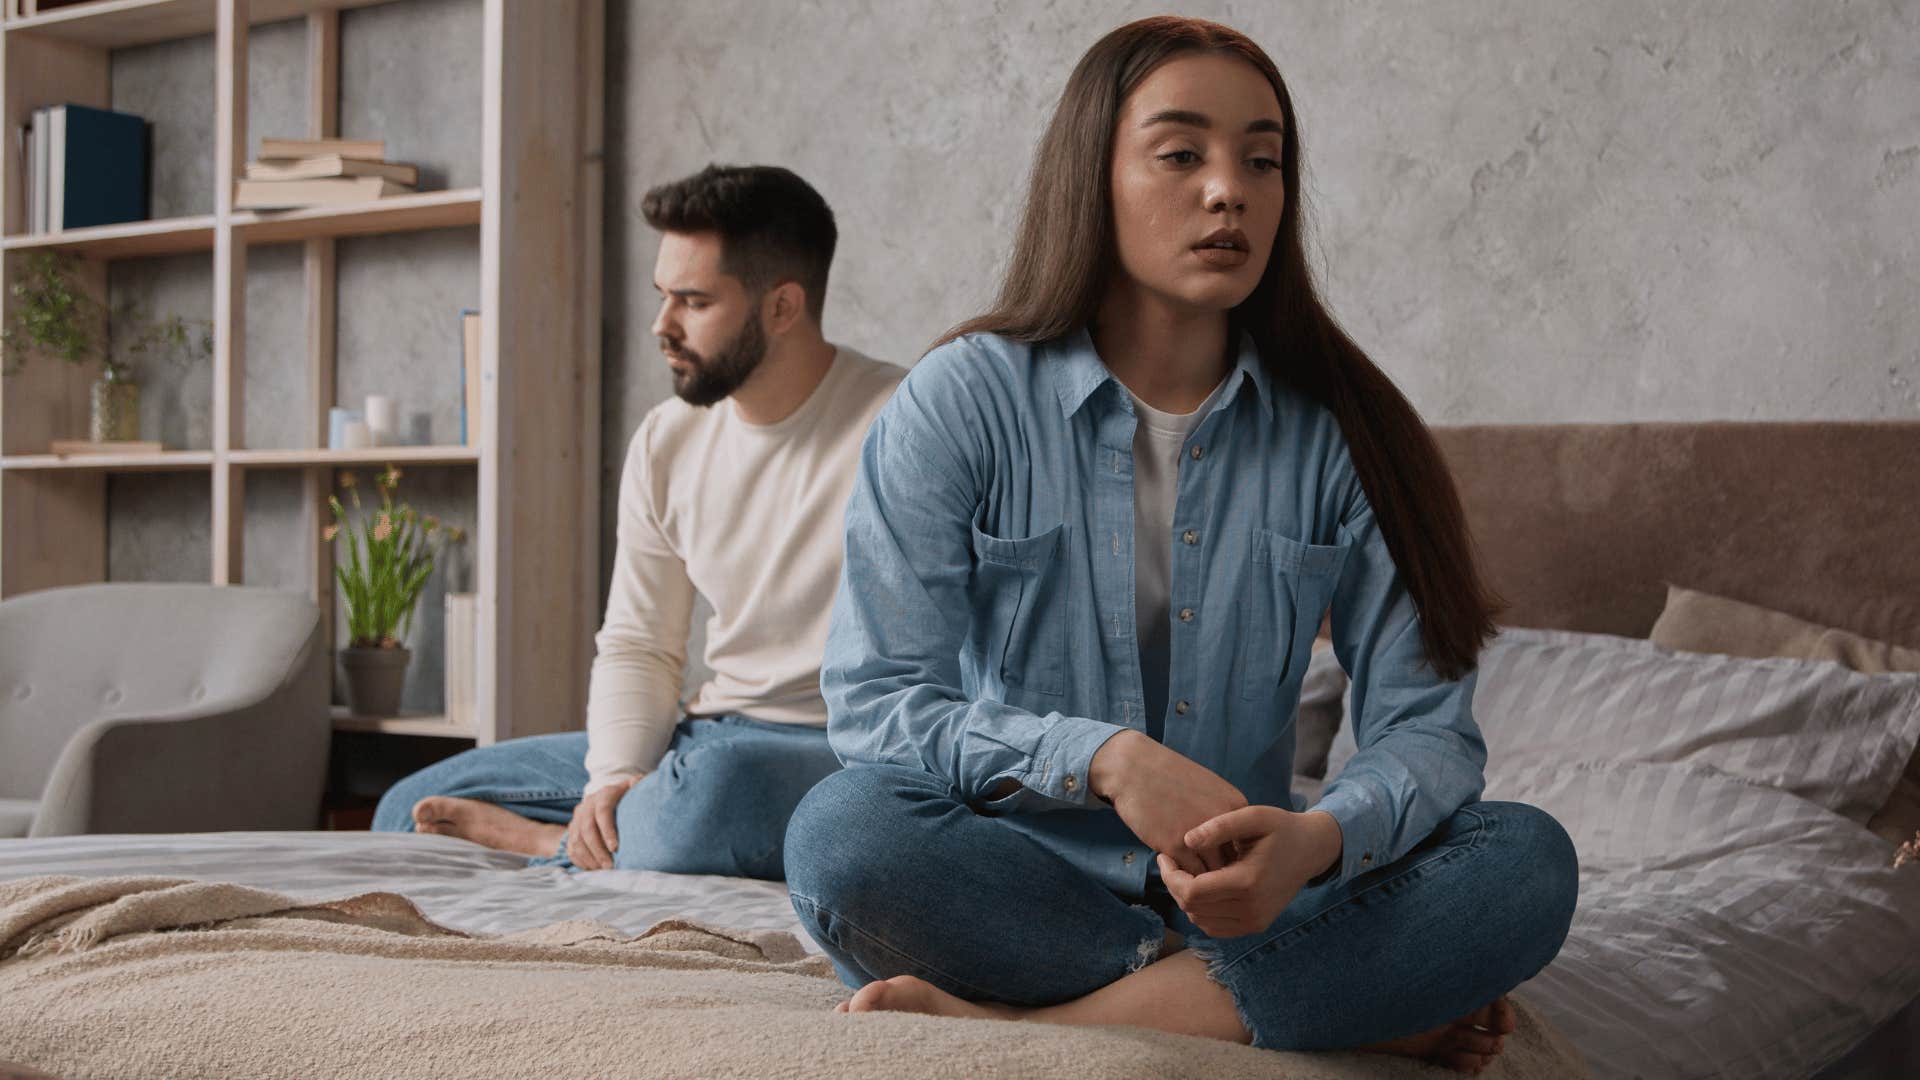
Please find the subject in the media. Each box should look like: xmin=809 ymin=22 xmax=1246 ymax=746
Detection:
xmin=1087 ymin=730 xmax=1246 ymax=874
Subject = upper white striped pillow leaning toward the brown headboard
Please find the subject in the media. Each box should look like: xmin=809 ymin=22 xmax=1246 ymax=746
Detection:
xmin=1327 ymin=626 xmax=1920 ymax=824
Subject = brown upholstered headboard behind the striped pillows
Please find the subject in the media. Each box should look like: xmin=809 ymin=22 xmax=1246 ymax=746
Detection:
xmin=1434 ymin=421 xmax=1920 ymax=648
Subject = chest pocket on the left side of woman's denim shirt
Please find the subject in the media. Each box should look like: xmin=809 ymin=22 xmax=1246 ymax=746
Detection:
xmin=972 ymin=521 xmax=1071 ymax=694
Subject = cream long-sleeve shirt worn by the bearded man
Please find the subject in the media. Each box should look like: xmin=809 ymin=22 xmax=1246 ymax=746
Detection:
xmin=586 ymin=346 xmax=906 ymax=792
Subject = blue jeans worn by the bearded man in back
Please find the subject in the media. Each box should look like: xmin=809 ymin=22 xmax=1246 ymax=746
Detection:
xmin=372 ymin=715 xmax=839 ymax=880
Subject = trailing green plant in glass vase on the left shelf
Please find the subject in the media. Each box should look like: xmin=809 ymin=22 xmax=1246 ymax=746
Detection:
xmin=0 ymin=252 xmax=213 ymax=442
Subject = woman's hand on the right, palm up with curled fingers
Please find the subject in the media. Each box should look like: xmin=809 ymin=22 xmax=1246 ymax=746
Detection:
xmin=1160 ymin=807 xmax=1340 ymax=938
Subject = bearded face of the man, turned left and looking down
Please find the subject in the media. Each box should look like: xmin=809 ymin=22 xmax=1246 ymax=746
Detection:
xmin=653 ymin=233 xmax=766 ymax=405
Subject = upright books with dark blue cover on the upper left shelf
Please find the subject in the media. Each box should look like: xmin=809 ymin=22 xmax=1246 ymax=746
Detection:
xmin=19 ymin=102 xmax=150 ymax=233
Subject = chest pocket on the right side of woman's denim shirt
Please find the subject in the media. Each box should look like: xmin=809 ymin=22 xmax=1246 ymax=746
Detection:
xmin=1240 ymin=528 xmax=1352 ymax=701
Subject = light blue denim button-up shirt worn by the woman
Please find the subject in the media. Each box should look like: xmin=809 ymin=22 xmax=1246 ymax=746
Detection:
xmin=820 ymin=322 xmax=1486 ymax=897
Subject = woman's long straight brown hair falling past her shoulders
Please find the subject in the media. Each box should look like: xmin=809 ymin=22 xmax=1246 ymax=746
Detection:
xmin=935 ymin=15 xmax=1501 ymax=678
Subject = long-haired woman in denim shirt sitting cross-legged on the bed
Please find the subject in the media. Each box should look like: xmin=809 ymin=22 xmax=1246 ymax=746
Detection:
xmin=787 ymin=17 xmax=1576 ymax=1072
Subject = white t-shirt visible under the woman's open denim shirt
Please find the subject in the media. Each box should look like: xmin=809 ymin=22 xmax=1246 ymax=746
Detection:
xmin=1127 ymin=379 xmax=1227 ymax=740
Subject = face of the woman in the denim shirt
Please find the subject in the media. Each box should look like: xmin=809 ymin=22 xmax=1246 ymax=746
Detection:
xmin=1112 ymin=54 xmax=1286 ymax=311
